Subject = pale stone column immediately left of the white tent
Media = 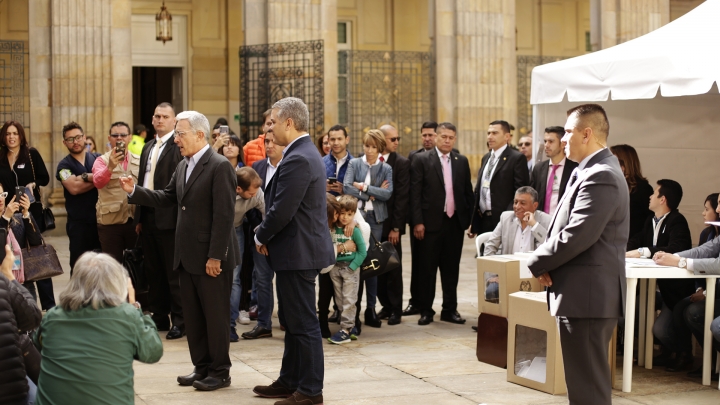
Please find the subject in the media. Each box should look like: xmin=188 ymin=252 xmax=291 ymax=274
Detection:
xmin=435 ymin=0 xmax=517 ymax=174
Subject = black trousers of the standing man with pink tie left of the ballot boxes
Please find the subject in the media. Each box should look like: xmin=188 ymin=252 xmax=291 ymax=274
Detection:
xmin=413 ymin=214 xmax=464 ymax=316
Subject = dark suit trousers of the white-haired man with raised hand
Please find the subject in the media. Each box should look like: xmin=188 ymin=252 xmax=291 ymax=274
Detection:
xmin=178 ymin=264 xmax=232 ymax=379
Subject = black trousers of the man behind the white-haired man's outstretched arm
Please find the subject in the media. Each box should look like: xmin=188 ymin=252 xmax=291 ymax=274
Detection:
xmin=140 ymin=207 xmax=185 ymax=330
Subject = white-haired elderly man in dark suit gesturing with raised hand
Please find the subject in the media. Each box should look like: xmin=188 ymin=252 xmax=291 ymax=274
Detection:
xmin=120 ymin=111 xmax=240 ymax=391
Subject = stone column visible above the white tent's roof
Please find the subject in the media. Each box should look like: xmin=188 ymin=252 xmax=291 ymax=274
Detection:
xmin=591 ymin=0 xmax=670 ymax=49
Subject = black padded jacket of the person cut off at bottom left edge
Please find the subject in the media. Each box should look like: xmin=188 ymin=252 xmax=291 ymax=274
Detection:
xmin=0 ymin=273 xmax=42 ymax=404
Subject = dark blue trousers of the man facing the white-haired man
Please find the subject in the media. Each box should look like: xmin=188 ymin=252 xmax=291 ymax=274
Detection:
xmin=276 ymin=270 xmax=325 ymax=396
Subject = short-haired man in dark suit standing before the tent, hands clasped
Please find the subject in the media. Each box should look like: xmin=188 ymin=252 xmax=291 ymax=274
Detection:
xmin=528 ymin=104 xmax=630 ymax=405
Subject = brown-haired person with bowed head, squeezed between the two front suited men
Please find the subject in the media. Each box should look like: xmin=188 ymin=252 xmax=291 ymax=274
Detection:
xmin=230 ymin=166 xmax=265 ymax=342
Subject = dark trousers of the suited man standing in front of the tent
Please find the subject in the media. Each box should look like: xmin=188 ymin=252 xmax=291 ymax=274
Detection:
xmin=556 ymin=316 xmax=618 ymax=405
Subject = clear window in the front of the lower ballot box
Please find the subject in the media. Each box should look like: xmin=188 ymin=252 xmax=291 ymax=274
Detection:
xmin=508 ymin=325 xmax=547 ymax=383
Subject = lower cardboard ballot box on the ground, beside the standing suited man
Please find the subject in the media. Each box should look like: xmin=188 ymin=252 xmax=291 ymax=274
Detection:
xmin=507 ymin=291 xmax=567 ymax=395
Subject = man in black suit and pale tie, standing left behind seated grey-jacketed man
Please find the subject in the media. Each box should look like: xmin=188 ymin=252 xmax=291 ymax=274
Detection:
xmin=468 ymin=120 xmax=530 ymax=238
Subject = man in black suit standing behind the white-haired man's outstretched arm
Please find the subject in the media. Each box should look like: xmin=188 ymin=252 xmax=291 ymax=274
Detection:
xmin=135 ymin=103 xmax=185 ymax=339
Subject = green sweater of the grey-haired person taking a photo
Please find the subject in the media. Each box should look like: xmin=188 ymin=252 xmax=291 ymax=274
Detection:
xmin=33 ymin=304 xmax=163 ymax=405
